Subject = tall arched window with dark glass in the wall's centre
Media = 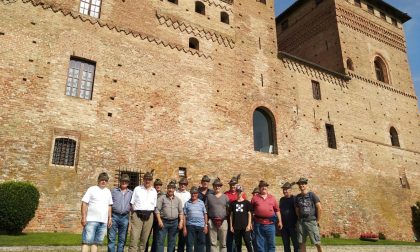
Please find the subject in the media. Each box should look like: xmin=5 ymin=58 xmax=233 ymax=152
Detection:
xmin=253 ymin=107 xmax=277 ymax=153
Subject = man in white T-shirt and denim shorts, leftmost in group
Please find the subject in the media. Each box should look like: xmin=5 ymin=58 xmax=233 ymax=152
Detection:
xmin=81 ymin=172 xmax=112 ymax=252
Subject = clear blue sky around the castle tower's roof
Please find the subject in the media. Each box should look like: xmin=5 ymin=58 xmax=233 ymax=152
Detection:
xmin=274 ymin=0 xmax=420 ymax=107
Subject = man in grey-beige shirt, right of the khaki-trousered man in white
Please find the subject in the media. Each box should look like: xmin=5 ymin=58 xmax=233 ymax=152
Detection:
xmin=153 ymin=181 xmax=184 ymax=252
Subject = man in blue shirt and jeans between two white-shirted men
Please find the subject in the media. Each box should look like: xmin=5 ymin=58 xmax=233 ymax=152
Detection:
xmin=108 ymin=174 xmax=133 ymax=252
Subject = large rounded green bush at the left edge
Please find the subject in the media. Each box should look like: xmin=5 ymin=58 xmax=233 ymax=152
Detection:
xmin=0 ymin=181 xmax=39 ymax=234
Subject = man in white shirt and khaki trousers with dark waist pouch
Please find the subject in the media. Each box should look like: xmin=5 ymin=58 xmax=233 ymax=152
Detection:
xmin=128 ymin=172 xmax=157 ymax=252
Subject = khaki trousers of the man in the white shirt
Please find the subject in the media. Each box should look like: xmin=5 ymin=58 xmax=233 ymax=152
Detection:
xmin=128 ymin=212 xmax=154 ymax=252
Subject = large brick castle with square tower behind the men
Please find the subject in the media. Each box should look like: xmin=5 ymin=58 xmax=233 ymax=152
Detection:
xmin=0 ymin=0 xmax=420 ymax=240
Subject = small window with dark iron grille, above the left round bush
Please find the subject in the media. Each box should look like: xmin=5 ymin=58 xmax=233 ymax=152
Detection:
xmin=52 ymin=138 xmax=76 ymax=166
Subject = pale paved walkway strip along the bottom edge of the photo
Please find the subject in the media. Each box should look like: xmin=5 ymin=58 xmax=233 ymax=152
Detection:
xmin=0 ymin=245 xmax=420 ymax=252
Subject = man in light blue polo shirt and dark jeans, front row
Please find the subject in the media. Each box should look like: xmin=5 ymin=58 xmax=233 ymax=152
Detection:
xmin=183 ymin=186 xmax=208 ymax=252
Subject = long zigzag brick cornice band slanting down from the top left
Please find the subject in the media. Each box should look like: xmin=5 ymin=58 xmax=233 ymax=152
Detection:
xmin=18 ymin=0 xmax=213 ymax=60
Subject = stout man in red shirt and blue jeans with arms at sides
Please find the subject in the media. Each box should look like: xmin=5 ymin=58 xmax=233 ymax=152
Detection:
xmin=251 ymin=180 xmax=282 ymax=252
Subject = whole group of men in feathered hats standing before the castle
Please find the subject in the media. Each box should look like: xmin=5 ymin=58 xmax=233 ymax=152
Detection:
xmin=81 ymin=173 xmax=322 ymax=252
